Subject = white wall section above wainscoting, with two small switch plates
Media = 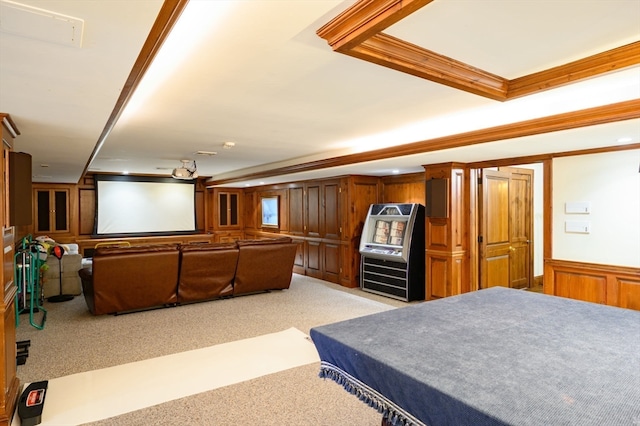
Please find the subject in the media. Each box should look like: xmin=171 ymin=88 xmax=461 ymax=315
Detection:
xmin=553 ymin=150 xmax=640 ymax=267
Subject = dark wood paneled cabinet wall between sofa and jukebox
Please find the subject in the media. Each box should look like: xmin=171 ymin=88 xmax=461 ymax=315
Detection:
xmin=236 ymin=176 xmax=379 ymax=287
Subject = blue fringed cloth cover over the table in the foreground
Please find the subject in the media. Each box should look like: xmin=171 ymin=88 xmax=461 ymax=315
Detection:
xmin=311 ymin=287 xmax=640 ymax=426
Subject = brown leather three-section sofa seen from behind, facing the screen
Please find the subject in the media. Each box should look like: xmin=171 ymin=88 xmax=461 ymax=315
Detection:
xmin=78 ymin=237 xmax=297 ymax=315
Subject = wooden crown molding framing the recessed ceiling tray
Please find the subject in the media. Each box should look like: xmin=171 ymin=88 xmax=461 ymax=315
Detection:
xmin=317 ymin=0 xmax=640 ymax=101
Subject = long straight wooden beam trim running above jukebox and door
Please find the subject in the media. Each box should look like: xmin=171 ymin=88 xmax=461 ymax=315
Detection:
xmin=207 ymin=99 xmax=640 ymax=186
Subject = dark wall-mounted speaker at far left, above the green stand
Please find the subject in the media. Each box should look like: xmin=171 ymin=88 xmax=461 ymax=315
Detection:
xmin=9 ymin=151 xmax=33 ymax=226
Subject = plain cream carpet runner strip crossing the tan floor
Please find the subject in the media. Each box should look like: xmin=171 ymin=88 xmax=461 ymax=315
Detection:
xmin=12 ymin=328 xmax=319 ymax=426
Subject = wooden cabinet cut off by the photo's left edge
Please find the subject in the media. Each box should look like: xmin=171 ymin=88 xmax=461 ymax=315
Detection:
xmin=0 ymin=113 xmax=20 ymax=425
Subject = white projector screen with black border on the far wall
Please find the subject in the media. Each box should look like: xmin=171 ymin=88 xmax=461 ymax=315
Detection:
xmin=94 ymin=175 xmax=196 ymax=236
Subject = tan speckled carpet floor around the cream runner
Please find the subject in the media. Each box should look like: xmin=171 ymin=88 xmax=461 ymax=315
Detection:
xmin=17 ymin=275 xmax=407 ymax=426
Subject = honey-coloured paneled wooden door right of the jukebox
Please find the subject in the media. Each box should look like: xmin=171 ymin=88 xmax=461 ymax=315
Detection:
xmin=478 ymin=168 xmax=533 ymax=288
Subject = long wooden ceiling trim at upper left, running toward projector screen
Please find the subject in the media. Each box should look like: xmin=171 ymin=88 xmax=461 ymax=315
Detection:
xmin=79 ymin=0 xmax=189 ymax=182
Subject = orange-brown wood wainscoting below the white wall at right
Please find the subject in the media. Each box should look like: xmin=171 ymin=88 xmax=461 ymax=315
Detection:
xmin=544 ymin=259 xmax=640 ymax=310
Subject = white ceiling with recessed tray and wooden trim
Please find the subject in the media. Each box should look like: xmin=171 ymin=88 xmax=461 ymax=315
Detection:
xmin=0 ymin=0 xmax=640 ymax=186
